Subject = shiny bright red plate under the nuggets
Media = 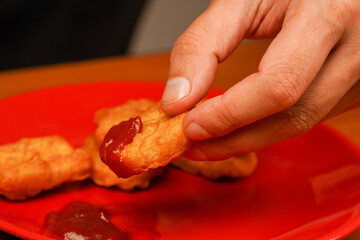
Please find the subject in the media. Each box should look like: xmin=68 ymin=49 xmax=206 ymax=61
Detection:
xmin=0 ymin=82 xmax=360 ymax=240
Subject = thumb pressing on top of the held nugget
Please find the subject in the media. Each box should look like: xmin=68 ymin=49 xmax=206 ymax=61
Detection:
xmin=162 ymin=0 xmax=260 ymax=115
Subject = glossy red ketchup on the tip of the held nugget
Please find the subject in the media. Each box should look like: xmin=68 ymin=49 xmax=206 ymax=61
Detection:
xmin=100 ymin=117 xmax=142 ymax=177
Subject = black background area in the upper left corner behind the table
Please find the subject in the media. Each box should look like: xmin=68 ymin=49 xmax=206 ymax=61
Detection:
xmin=0 ymin=0 xmax=146 ymax=70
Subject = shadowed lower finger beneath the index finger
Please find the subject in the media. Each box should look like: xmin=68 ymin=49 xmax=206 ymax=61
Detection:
xmin=186 ymin=36 xmax=360 ymax=160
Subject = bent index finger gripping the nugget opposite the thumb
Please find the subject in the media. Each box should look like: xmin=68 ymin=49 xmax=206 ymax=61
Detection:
xmin=183 ymin=0 xmax=343 ymax=140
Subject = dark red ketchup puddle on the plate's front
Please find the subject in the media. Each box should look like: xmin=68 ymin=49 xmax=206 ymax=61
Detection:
xmin=45 ymin=201 xmax=130 ymax=240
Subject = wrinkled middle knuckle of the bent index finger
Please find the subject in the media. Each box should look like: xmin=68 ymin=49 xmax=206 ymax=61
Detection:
xmin=268 ymin=71 xmax=303 ymax=109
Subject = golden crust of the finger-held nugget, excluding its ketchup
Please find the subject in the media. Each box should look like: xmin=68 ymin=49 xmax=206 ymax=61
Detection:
xmin=103 ymin=103 xmax=190 ymax=178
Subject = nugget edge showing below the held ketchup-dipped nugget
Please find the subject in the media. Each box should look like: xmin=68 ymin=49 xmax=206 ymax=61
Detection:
xmin=83 ymin=136 xmax=165 ymax=191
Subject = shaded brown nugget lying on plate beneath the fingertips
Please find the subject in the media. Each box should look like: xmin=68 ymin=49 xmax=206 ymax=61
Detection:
xmin=171 ymin=153 xmax=258 ymax=180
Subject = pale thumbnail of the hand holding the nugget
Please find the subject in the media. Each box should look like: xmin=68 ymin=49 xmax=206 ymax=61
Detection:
xmin=161 ymin=77 xmax=190 ymax=105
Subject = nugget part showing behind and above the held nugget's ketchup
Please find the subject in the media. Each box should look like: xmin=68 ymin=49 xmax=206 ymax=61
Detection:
xmin=95 ymin=99 xmax=156 ymax=145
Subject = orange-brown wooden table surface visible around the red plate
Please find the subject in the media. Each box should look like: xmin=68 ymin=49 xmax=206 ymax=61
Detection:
xmin=0 ymin=42 xmax=360 ymax=240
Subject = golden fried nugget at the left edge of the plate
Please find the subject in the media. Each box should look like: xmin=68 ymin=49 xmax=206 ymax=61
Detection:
xmin=0 ymin=135 xmax=91 ymax=200
